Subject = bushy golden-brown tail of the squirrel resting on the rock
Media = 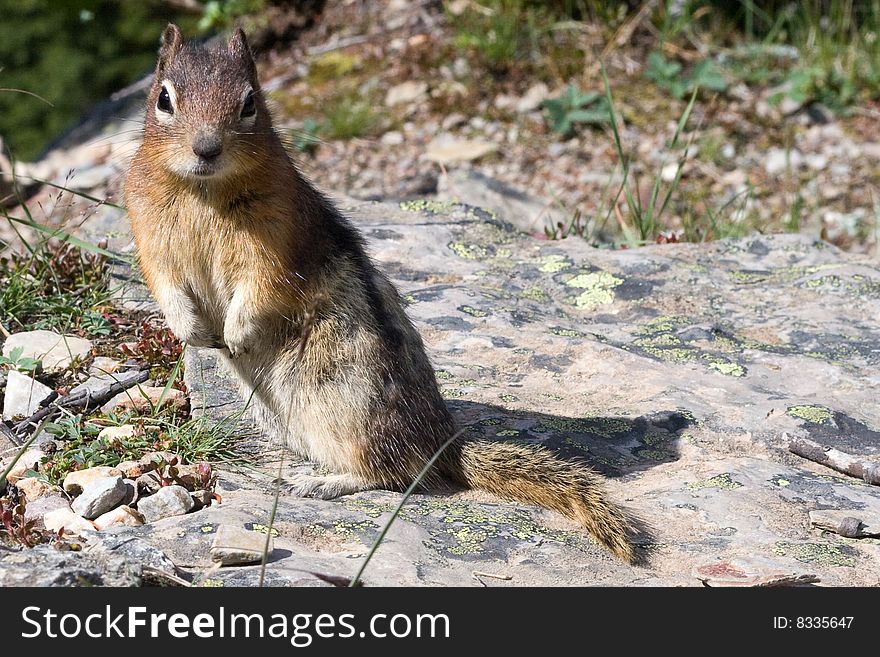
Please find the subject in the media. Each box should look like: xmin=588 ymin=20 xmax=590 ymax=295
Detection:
xmin=445 ymin=440 xmax=636 ymax=563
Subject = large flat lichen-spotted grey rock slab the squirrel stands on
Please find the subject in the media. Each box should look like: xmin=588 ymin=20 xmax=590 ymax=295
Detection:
xmin=0 ymin=202 xmax=880 ymax=586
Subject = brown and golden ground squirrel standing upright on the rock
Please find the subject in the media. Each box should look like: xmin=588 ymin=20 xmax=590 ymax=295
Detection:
xmin=125 ymin=25 xmax=634 ymax=561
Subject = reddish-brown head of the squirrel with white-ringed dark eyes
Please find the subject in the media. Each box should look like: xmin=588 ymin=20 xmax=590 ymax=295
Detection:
xmin=144 ymin=24 xmax=272 ymax=182
